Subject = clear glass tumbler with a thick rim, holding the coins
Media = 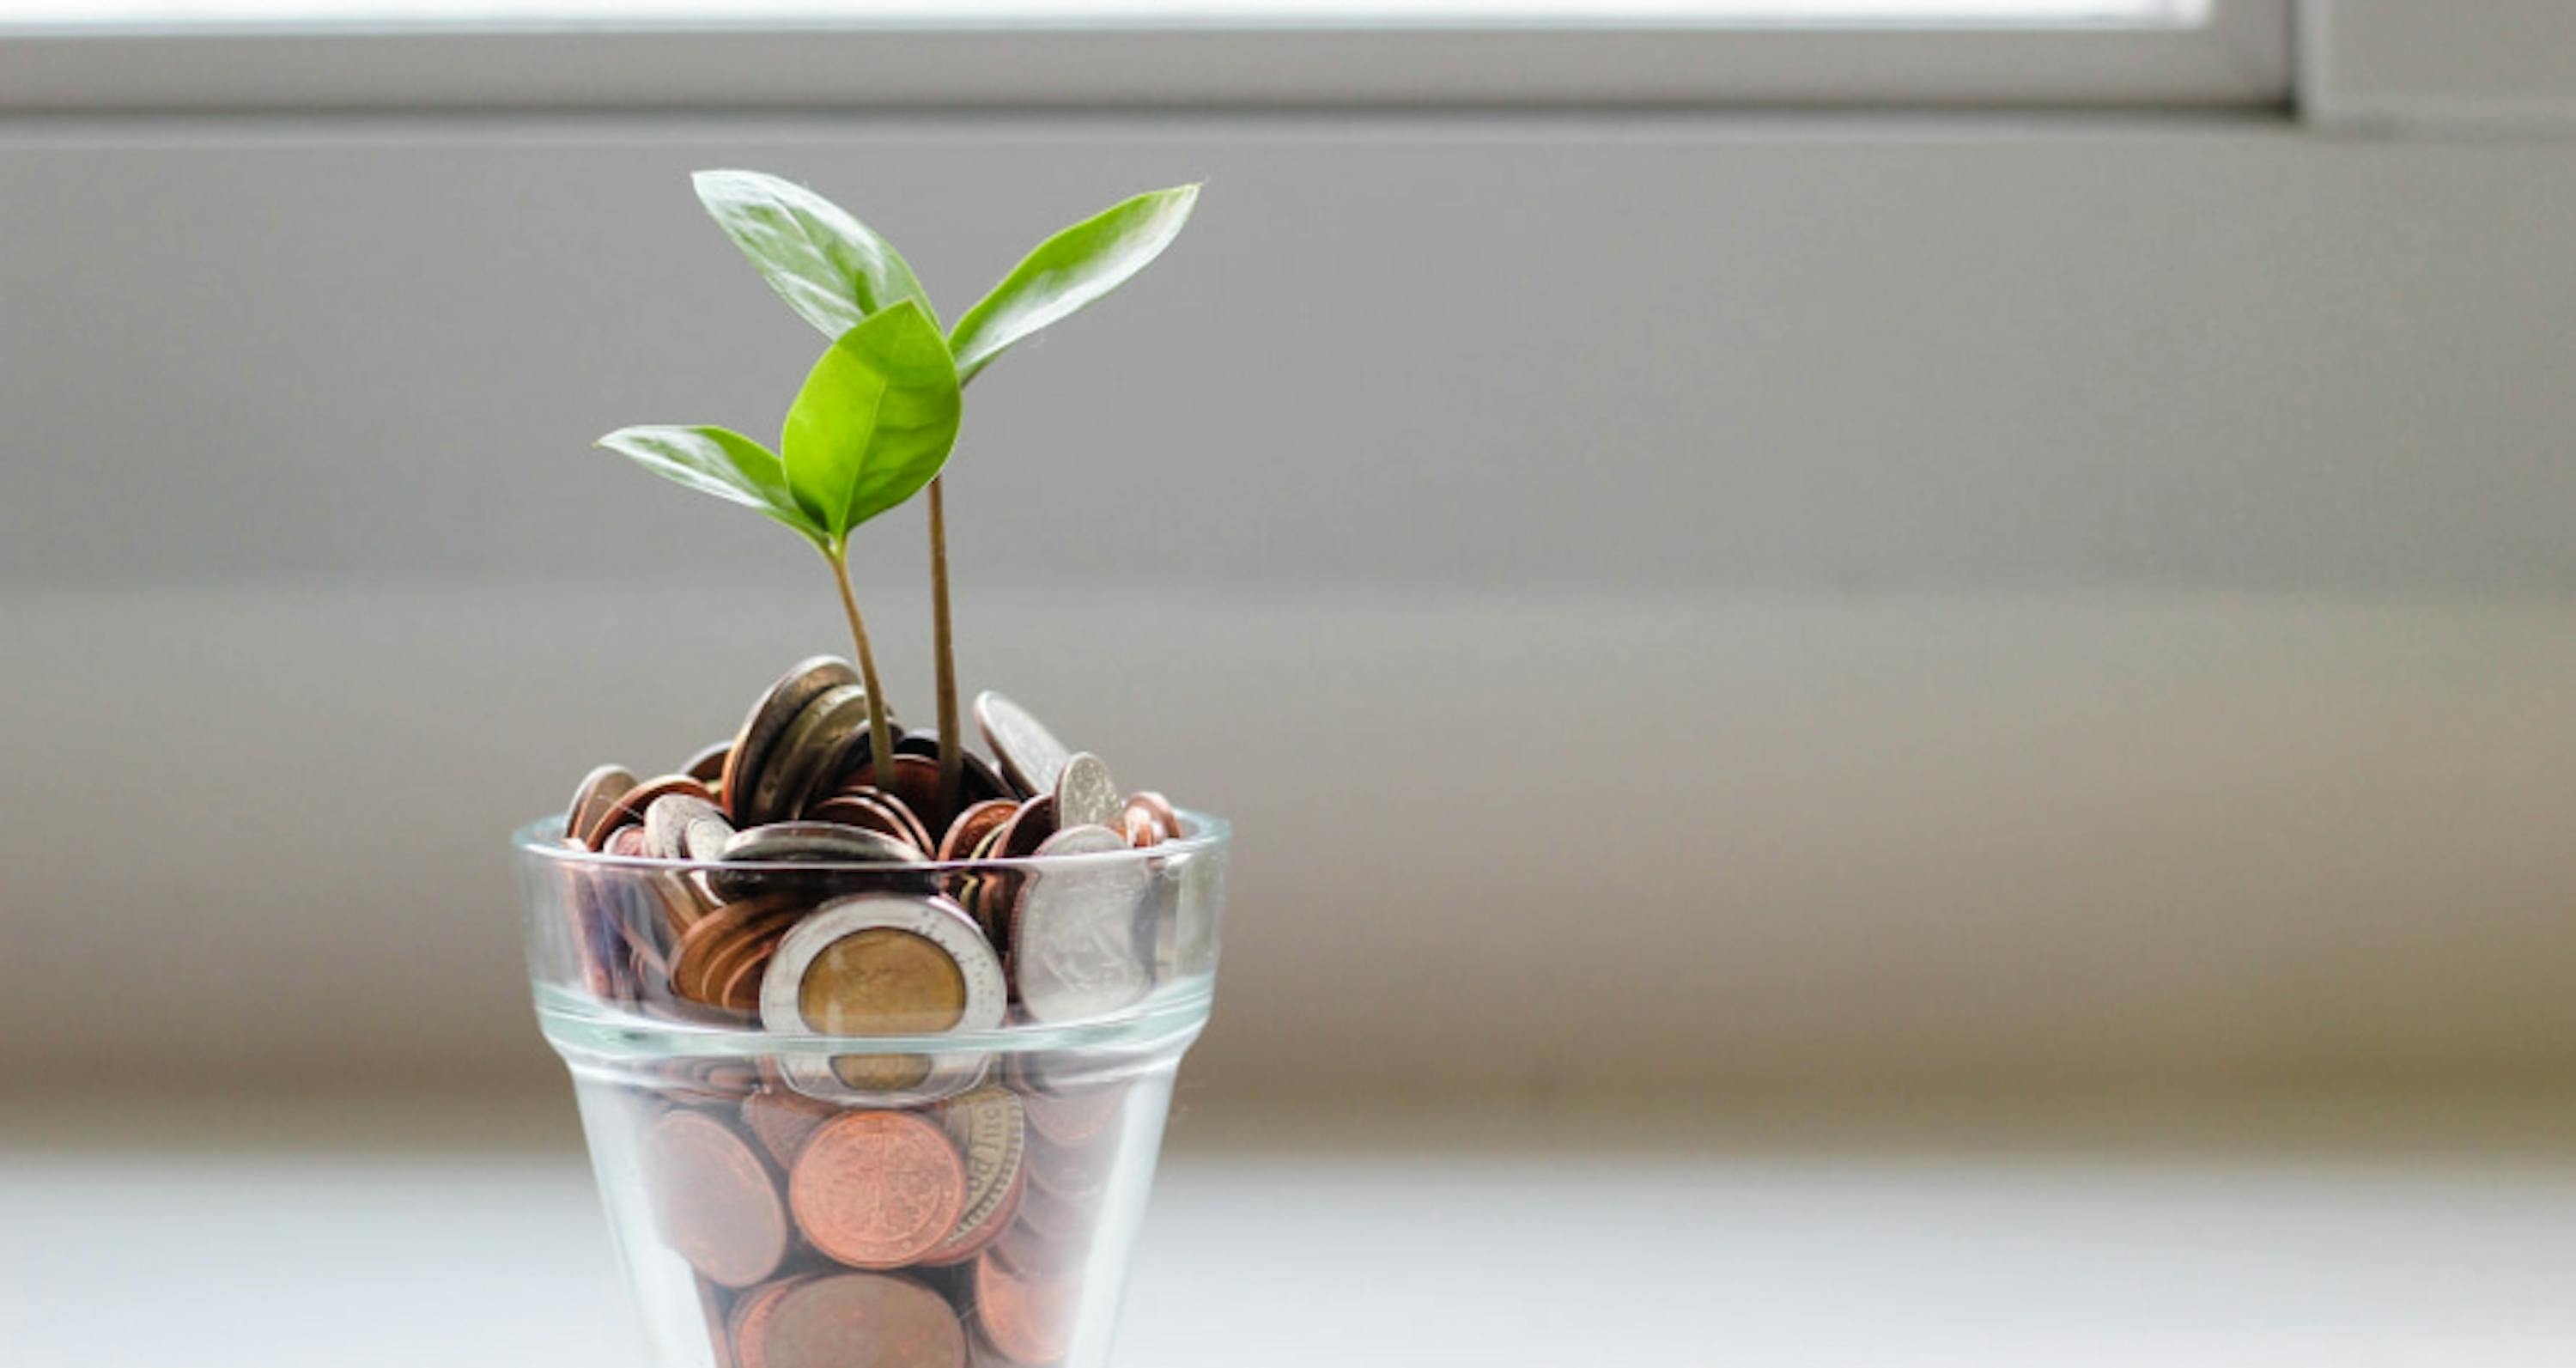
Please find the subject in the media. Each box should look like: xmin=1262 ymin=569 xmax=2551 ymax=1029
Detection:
xmin=518 ymin=814 xmax=1226 ymax=1368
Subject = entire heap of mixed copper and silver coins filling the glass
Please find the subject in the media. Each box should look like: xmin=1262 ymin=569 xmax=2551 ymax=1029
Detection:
xmin=564 ymin=657 xmax=1193 ymax=1368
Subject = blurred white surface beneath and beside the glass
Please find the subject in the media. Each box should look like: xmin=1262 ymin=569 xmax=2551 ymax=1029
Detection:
xmin=0 ymin=1116 xmax=2576 ymax=1368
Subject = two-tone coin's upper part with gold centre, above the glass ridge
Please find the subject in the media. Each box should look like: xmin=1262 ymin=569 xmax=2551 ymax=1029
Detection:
xmin=760 ymin=894 xmax=1010 ymax=1036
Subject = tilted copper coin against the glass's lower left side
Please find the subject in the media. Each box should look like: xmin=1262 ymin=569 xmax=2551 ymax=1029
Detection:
xmin=644 ymin=1110 xmax=788 ymax=1288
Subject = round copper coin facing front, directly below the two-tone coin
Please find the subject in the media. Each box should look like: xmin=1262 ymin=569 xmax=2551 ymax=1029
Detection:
xmin=788 ymin=1110 xmax=966 ymax=1268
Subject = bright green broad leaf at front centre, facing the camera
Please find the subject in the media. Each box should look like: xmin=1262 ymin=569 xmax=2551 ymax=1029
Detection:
xmin=778 ymin=299 xmax=961 ymax=544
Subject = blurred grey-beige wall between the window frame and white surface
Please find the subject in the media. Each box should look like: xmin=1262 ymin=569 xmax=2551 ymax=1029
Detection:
xmin=0 ymin=116 xmax=2576 ymax=1095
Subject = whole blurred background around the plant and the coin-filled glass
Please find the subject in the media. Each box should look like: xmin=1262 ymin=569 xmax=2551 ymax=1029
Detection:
xmin=0 ymin=0 xmax=2576 ymax=1365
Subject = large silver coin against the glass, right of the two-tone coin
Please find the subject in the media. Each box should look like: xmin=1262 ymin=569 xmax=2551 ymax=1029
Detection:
xmin=1010 ymin=827 xmax=1154 ymax=1023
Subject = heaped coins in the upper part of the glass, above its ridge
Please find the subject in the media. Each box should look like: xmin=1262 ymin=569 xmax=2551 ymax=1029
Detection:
xmin=564 ymin=657 xmax=1182 ymax=1036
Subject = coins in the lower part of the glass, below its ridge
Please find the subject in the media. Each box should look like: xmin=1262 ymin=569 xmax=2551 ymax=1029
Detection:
xmin=639 ymin=1069 xmax=1126 ymax=1368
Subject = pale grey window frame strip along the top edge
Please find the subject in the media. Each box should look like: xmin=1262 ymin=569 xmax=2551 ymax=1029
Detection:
xmin=0 ymin=0 xmax=2295 ymax=113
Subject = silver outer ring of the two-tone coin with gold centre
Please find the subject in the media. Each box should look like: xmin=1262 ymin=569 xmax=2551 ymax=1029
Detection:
xmin=760 ymin=894 xmax=1010 ymax=1108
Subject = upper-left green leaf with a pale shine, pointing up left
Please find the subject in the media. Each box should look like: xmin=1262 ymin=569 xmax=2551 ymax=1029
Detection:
xmin=690 ymin=170 xmax=938 ymax=337
